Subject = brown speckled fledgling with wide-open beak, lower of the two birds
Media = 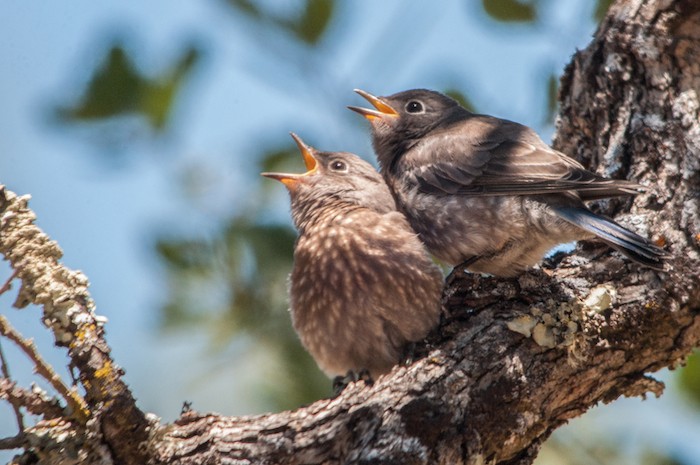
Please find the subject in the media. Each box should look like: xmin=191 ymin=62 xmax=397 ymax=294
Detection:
xmin=263 ymin=134 xmax=443 ymax=378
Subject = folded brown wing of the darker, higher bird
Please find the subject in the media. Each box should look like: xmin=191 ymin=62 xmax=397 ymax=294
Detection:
xmin=404 ymin=117 xmax=641 ymax=200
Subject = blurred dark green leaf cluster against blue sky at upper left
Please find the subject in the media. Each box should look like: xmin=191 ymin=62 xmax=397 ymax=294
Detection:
xmin=55 ymin=45 xmax=200 ymax=130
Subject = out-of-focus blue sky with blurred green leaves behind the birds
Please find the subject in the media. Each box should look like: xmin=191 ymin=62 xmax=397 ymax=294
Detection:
xmin=0 ymin=0 xmax=700 ymax=465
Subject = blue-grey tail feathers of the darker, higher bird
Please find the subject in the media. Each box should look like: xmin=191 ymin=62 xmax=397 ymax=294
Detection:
xmin=554 ymin=206 xmax=669 ymax=270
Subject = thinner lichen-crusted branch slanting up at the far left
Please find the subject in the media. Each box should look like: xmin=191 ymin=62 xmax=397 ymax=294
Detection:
xmin=0 ymin=186 xmax=150 ymax=464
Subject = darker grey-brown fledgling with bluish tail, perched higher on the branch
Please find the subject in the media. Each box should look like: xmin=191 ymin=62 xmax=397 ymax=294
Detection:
xmin=349 ymin=89 xmax=666 ymax=276
